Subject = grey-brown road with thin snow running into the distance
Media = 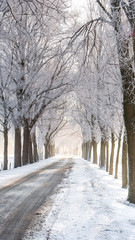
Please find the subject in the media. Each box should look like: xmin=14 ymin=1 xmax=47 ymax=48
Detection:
xmin=0 ymin=159 xmax=72 ymax=240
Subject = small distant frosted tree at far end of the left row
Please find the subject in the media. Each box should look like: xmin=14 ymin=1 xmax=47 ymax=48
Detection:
xmin=37 ymin=101 xmax=68 ymax=158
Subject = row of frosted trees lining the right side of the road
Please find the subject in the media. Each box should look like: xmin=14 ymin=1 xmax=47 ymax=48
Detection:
xmin=70 ymin=0 xmax=135 ymax=203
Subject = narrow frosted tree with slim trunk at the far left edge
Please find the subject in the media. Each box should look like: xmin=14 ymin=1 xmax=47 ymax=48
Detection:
xmin=0 ymin=34 xmax=12 ymax=170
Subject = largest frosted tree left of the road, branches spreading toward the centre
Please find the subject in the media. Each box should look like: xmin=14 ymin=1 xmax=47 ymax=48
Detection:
xmin=2 ymin=0 xmax=75 ymax=166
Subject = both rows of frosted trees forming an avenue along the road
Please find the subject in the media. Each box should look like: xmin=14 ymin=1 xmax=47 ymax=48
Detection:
xmin=0 ymin=0 xmax=135 ymax=203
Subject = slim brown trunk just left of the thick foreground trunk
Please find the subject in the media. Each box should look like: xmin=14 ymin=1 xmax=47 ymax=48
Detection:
xmin=122 ymin=134 xmax=128 ymax=188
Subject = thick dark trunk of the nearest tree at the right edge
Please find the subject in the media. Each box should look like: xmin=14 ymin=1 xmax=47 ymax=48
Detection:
xmin=121 ymin=40 xmax=135 ymax=203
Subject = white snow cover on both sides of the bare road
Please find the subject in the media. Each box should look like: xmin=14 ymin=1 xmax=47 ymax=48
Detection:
xmin=0 ymin=158 xmax=135 ymax=240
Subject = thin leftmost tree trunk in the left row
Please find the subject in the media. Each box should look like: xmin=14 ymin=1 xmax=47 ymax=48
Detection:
xmin=3 ymin=128 xmax=8 ymax=170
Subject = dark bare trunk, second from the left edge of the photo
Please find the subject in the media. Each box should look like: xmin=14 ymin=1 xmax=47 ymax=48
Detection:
xmin=14 ymin=127 xmax=22 ymax=168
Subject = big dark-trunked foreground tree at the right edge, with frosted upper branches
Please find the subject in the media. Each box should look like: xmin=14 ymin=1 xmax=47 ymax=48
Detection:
xmin=97 ymin=0 xmax=135 ymax=203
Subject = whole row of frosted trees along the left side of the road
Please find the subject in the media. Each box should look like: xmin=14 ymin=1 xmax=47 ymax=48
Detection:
xmin=0 ymin=0 xmax=73 ymax=169
